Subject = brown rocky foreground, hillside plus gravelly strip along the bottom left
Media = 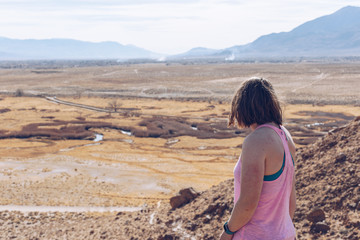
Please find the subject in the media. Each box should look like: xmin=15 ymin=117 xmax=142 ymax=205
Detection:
xmin=0 ymin=117 xmax=360 ymax=240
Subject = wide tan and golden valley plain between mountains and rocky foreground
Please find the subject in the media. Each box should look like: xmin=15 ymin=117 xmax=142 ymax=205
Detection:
xmin=0 ymin=62 xmax=360 ymax=239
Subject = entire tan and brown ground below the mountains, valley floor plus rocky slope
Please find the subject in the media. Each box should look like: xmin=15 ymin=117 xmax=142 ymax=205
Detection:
xmin=0 ymin=63 xmax=360 ymax=239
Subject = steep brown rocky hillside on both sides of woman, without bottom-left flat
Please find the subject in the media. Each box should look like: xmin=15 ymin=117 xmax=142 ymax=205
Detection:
xmin=128 ymin=119 xmax=360 ymax=239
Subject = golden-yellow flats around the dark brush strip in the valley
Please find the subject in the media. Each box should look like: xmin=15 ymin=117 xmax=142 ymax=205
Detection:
xmin=0 ymin=97 xmax=360 ymax=207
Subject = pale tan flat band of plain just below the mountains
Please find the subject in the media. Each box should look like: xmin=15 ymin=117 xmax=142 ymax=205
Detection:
xmin=0 ymin=62 xmax=360 ymax=104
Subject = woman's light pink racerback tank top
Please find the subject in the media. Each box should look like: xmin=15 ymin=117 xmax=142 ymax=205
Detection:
xmin=232 ymin=124 xmax=296 ymax=240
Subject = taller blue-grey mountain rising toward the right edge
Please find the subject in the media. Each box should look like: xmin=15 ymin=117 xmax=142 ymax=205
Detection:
xmin=179 ymin=6 xmax=360 ymax=60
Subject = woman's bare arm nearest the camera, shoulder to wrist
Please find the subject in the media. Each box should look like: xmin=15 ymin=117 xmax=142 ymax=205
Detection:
xmin=222 ymin=133 xmax=265 ymax=237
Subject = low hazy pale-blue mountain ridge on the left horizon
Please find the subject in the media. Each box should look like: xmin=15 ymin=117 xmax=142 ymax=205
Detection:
xmin=0 ymin=37 xmax=160 ymax=60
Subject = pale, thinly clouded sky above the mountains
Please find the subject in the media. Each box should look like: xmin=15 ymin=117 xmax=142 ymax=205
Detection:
xmin=0 ymin=0 xmax=360 ymax=54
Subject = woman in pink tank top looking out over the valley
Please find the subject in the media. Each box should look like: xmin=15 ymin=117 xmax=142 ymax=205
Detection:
xmin=220 ymin=78 xmax=296 ymax=240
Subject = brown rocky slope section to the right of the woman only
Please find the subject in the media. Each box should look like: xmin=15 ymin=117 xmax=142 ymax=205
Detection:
xmin=295 ymin=117 xmax=360 ymax=239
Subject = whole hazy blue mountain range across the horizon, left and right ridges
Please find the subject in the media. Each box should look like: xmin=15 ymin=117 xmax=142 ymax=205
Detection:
xmin=0 ymin=6 xmax=360 ymax=61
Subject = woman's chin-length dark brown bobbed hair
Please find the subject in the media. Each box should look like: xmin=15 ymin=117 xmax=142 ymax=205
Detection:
xmin=228 ymin=78 xmax=282 ymax=127
